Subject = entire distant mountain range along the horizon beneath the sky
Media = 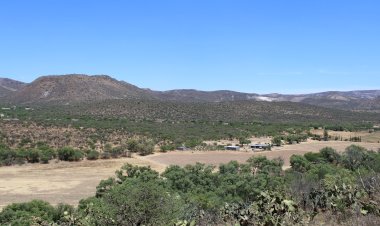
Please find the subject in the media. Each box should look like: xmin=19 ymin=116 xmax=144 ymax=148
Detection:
xmin=0 ymin=74 xmax=380 ymax=112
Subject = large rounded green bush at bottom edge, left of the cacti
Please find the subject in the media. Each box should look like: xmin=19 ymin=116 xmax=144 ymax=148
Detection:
xmin=80 ymin=179 xmax=184 ymax=225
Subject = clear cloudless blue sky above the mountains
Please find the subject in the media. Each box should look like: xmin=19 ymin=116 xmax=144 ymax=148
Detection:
xmin=0 ymin=0 xmax=380 ymax=93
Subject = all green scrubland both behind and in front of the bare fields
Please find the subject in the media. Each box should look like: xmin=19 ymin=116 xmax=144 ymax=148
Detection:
xmin=0 ymin=101 xmax=380 ymax=226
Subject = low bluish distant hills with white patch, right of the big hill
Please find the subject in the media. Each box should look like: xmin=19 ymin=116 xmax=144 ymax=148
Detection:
xmin=154 ymin=90 xmax=380 ymax=111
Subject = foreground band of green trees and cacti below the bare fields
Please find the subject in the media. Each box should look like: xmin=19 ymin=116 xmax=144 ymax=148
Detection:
xmin=0 ymin=145 xmax=380 ymax=225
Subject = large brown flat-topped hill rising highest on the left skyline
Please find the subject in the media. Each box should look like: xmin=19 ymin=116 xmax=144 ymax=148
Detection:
xmin=8 ymin=74 xmax=149 ymax=104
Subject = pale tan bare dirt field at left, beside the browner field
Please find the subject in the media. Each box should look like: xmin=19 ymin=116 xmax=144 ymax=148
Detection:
xmin=0 ymin=158 xmax=162 ymax=209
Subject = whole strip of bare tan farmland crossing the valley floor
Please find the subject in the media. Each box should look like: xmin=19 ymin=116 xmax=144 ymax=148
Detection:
xmin=0 ymin=141 xmax=380 ymax=209
